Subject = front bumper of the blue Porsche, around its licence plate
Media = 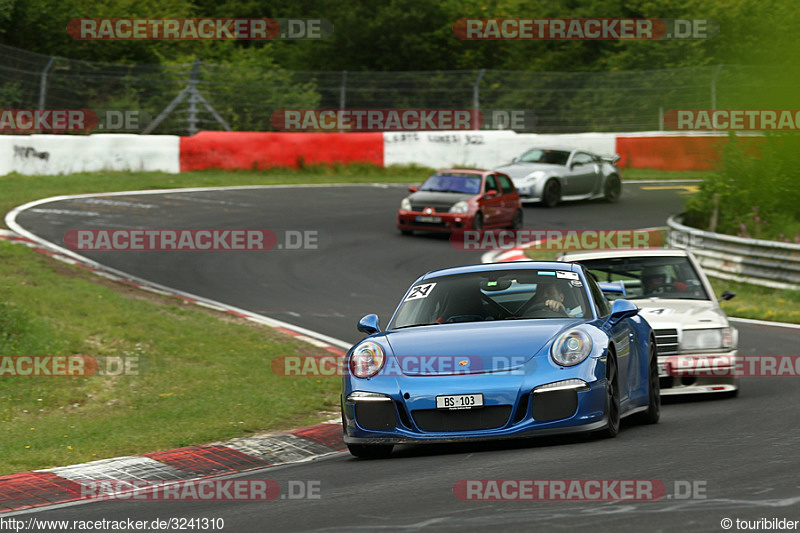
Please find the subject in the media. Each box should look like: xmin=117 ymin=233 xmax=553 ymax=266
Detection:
xmin=342 ymin=358 xmax=607 ymax=444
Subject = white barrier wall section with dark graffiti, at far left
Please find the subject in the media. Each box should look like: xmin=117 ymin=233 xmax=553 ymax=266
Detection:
xmin=0 ymin=134 xmax=180 ymax=175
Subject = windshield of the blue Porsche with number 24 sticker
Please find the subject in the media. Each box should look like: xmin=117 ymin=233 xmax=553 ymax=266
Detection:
xmin=389 ymin=270 xmax=592 ymax=329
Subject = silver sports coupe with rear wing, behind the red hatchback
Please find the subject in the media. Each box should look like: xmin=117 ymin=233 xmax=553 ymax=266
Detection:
xmin=495 ymin=148 xmax=622 ymax=207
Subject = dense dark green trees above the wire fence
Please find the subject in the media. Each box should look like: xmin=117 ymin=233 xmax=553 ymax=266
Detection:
xmin=0 ymin=0 xmax=800 ymax=71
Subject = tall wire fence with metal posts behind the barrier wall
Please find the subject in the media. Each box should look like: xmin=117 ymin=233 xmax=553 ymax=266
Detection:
xmin=0 ymin=45 xmax=793 ymax=135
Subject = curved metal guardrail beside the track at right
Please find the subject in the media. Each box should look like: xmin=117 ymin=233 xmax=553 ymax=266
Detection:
xmin=667 ymin=215 xmax=800 ymax=290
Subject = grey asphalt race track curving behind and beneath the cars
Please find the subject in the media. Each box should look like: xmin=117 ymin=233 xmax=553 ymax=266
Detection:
xmin=7 ymin=184 xmax=800 ymax=532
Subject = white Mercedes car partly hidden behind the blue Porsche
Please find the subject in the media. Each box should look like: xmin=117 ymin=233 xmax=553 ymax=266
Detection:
xmin=559 ymin=249 xmax=739 ymax=396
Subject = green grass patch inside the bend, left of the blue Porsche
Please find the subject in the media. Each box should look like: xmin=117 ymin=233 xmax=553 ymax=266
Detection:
xmin=0 ymin=241 xmax=340 ymax=474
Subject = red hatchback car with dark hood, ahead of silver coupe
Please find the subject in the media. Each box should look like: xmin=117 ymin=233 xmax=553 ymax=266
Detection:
xmin=397 ymin=169 xmax=522 ymax=235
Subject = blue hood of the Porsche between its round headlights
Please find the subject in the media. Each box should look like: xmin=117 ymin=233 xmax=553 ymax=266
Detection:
xmin=376 ymin=318 xmax=583 ymax=376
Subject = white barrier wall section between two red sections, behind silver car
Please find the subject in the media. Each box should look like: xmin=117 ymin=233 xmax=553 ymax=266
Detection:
xmin=383 ymin=131 xmax=617 ymax=168
